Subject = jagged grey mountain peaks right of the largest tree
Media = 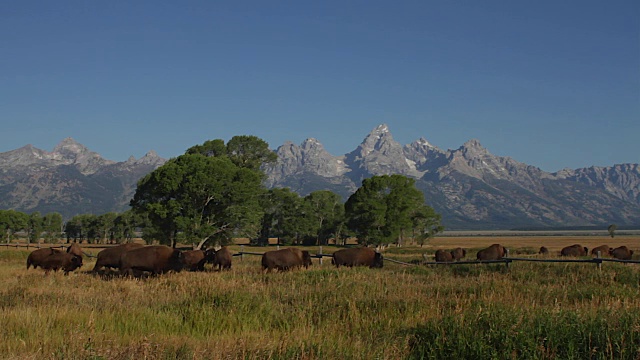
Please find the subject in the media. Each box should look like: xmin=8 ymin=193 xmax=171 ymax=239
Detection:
xmin=267 ymin=124 xmax=640 ymax=229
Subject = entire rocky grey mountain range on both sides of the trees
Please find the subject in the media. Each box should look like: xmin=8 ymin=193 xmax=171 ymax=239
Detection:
xmin=0 ymin=124 xmax=640 ymax=230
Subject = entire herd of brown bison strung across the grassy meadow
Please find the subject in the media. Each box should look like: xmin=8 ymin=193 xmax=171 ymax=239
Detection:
xmin=22 ymin=243 xmax=633 ymax=276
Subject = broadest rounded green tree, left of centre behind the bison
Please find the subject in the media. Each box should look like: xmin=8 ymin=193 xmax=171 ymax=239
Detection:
xmin=131 ymin=152 xmax=263 ymax=247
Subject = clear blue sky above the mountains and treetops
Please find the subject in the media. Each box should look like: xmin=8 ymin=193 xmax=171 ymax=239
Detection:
xmin=0 ymin=0 xmax=640 ymax=172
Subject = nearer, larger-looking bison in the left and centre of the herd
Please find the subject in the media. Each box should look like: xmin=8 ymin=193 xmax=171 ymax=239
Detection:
xmin=27 ymin=243 xmax=383 ymax=276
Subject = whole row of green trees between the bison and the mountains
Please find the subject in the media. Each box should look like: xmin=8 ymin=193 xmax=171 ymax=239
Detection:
xmin=0 ymin=136 xmax=443 ymax=247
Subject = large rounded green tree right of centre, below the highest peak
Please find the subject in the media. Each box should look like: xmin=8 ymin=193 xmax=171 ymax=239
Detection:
xmin=345 ymin=175 xmax=439 ymax=245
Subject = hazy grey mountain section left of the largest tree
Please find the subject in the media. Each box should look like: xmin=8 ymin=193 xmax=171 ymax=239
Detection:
xmin=0 ymin=138 xmax=166 ymax=219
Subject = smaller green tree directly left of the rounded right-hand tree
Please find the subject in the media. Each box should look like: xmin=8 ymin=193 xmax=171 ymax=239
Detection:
xmin=304 ymin=190 xmax=344 ymax=245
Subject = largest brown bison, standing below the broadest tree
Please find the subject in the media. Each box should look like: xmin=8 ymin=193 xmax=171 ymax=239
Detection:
xmin=119 ymin=245 xmax=184 ymax=275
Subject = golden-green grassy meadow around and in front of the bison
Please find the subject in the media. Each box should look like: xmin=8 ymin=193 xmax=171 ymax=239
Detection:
xmin=0 ymin=236 xmax=640 ymax=359
